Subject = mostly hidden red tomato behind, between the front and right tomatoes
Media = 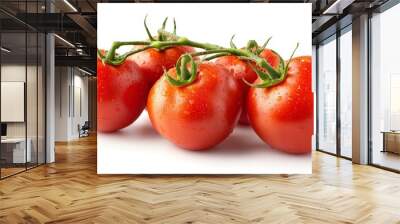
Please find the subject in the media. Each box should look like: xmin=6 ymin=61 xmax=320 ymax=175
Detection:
xmin=215 ymin=49 xmax=279 ymax=125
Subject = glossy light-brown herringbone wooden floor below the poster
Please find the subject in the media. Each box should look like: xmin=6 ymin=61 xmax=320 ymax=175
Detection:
xmin=0 ymin=136 xmax=400 ymax=224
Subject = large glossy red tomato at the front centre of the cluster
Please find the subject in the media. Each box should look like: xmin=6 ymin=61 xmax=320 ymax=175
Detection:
xmin=147 ymin=63 xmax=242 ymax=150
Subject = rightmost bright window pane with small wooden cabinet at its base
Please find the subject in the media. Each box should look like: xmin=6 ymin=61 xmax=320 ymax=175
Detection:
xmin=370 ymin=4 xmax=400 ymax=171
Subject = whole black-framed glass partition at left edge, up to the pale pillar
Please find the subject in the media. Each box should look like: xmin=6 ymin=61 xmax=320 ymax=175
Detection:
xmin=0 ymin=1 xmax=46 ymax=179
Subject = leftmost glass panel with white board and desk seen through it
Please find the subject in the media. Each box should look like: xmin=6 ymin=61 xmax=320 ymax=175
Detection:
xmin=0 ymin=32 xmax=27 ymax=178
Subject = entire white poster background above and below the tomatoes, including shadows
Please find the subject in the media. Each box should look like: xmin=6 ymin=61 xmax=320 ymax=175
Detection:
xmin=97 ymin=3 xmax=311 ymax=174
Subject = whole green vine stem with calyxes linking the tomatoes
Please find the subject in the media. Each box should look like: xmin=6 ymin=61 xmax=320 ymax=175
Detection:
xmin=97 ymin=16 xmax=298 ymax=88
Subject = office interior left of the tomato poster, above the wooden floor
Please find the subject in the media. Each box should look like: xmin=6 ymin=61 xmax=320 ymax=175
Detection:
xmin=0 ymin=0 xmax=96 ymax=179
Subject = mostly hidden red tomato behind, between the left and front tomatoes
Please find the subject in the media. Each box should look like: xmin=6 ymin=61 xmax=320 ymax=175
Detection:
xmin=130 ymin=46 xmax=194 ymax=86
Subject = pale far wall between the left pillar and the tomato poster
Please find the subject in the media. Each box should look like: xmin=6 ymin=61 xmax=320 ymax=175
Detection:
xmin=55 ymin=67 xmax=88 ymax=141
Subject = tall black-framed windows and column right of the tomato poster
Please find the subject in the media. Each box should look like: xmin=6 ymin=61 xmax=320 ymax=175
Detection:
xmin=313 ymin=1 xmax=400 ymax=172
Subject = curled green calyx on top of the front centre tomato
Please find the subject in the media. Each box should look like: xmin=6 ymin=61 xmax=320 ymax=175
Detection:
xmin=164 ymin=54 xmax=197 ymax=86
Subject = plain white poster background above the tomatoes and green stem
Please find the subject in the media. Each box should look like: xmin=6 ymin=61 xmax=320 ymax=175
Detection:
xmin=97 ymin=3 xmax=311 ymax=59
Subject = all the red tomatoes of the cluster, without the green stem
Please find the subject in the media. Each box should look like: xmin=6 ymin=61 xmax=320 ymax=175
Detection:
xmin=97 ymin=28 xmax=313 ymax=154
